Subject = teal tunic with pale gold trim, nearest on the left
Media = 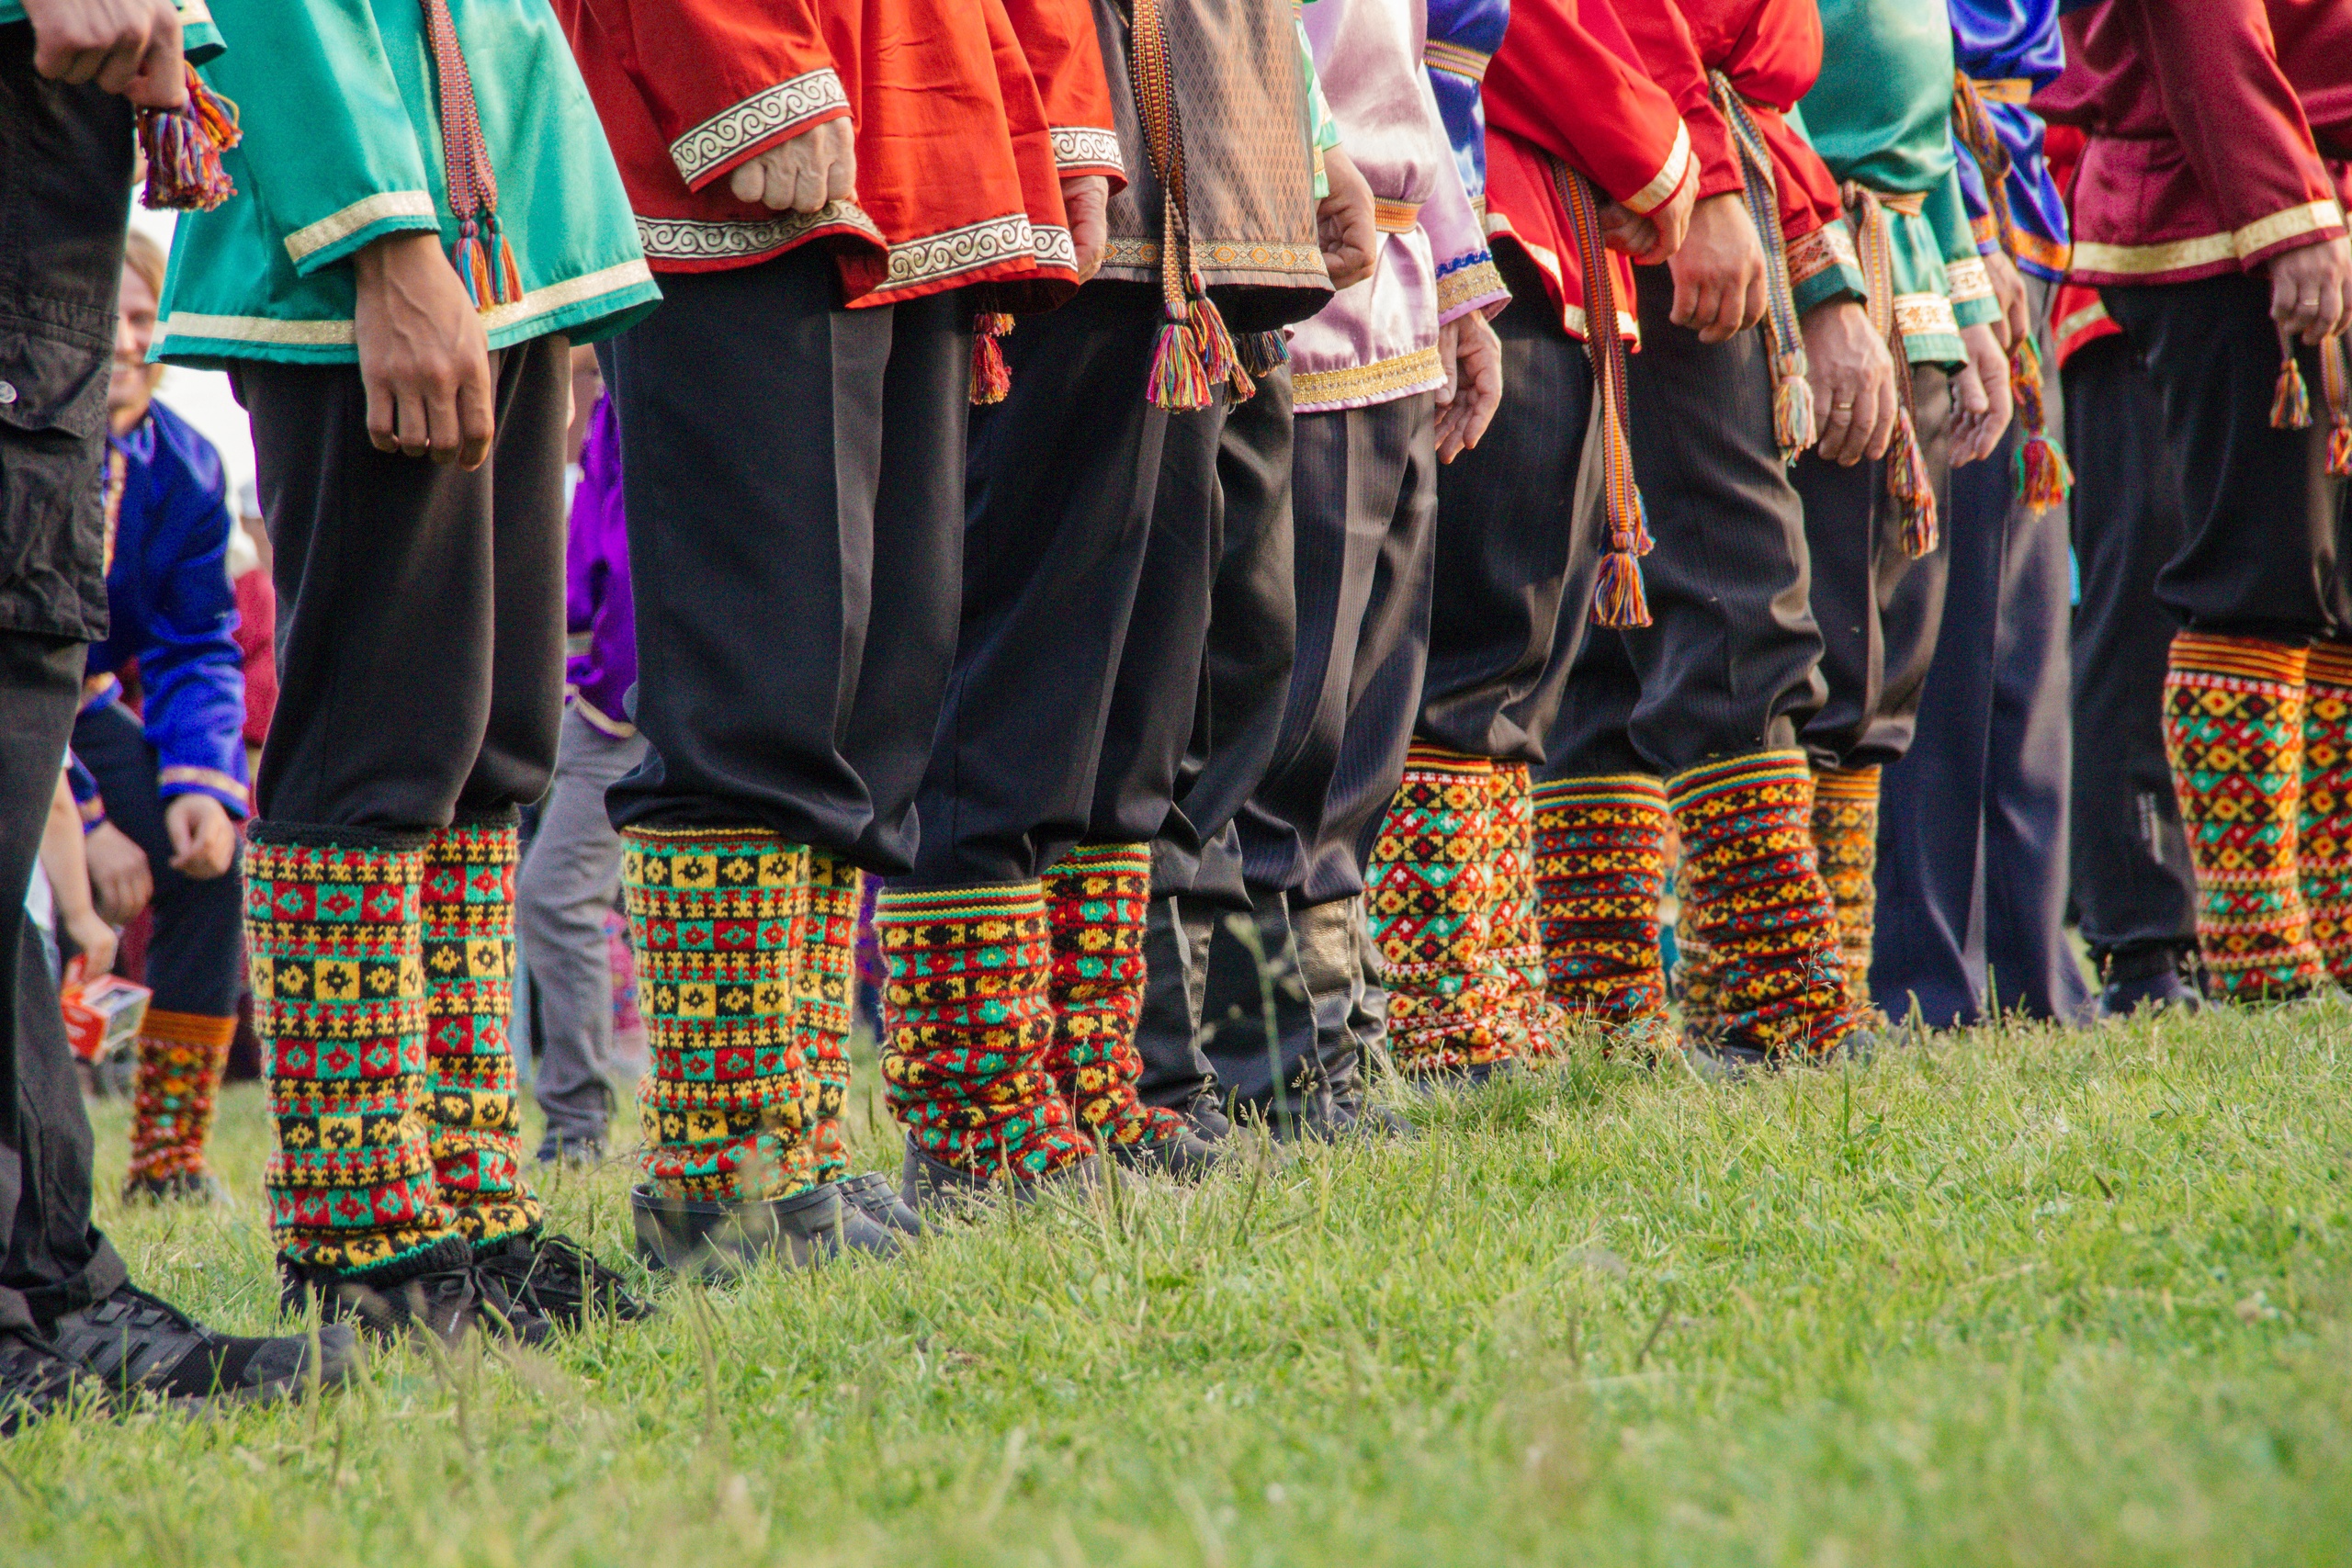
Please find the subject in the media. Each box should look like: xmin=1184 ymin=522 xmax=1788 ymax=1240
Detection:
xmin=153 ymin=0 xmax=661 ymax=367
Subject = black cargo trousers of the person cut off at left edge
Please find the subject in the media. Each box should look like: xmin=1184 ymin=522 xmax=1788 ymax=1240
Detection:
xmin=0 ymin=24 xmax=131 ymax=1328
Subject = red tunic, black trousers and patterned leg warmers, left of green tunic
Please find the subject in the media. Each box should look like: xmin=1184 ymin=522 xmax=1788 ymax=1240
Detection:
xmin=1536 ymin=0 xmax=1863 ymax=1060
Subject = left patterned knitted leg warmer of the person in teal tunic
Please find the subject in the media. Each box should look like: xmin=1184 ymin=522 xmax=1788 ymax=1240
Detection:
xmin=244 ymin=823 xmax=468 ymax=1283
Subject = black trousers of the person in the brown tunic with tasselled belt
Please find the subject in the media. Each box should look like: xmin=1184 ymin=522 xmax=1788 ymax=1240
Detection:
xmin=912 ymin=280 xmax=1226 ymax=886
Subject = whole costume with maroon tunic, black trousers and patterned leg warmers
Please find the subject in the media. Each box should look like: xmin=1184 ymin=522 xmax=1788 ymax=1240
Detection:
xmin=2041 ymin=0 xmax=2352 ymax=999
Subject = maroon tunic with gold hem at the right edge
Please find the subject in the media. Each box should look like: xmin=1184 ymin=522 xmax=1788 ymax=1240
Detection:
xmin=2034 ymin=0 xmax=2352 ymax=285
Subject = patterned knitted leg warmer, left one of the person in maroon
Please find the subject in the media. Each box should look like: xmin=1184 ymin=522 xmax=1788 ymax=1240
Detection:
xmin=2164 ymin=632 xmax=2326 ymax=1001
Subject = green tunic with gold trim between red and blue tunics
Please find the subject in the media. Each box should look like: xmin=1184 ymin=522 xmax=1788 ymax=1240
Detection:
xmin=1790 ymin=0 xmax=1999 ymax=365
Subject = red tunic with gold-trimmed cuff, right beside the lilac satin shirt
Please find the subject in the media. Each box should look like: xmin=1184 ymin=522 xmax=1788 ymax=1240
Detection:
xmin=1484 ymin=0 xmax=1698 ymax=339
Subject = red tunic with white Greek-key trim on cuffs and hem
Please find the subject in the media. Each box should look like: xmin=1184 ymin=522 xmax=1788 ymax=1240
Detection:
xmin=555 ymin=0 xmax=1125 ymax=306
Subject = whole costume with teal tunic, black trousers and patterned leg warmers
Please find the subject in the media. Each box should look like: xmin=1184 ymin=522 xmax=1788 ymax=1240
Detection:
xmin=155 ymin=0 xmax=659 ymax=1337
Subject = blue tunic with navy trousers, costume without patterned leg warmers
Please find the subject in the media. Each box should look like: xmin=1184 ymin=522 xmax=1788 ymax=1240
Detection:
xmin=1870 ymin=0 xmax=2091 ymax=1027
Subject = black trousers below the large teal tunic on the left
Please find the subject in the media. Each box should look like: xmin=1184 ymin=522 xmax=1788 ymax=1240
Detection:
xmin=231 ymin=336 xmax=571 ymax=829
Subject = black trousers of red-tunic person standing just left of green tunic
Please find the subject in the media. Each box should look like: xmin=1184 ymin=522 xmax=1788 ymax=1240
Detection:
xmin=1543 ymin=265 xmax=1823 ymax=778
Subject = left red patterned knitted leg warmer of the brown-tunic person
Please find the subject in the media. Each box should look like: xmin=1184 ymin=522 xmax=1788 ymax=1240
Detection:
xmin=875 ymin=882 xmax=1096 ymax=1182
